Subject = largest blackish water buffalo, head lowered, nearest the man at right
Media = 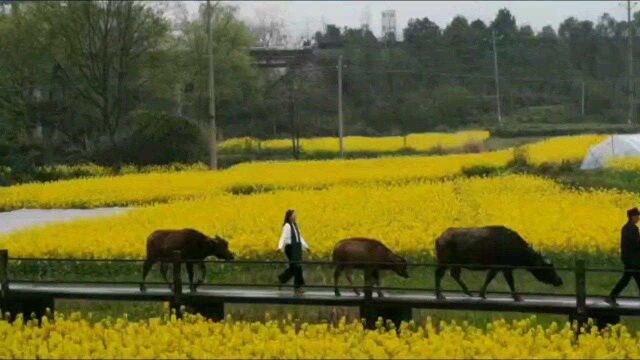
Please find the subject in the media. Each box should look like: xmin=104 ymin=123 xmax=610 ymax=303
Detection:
xmin=436 ymin=226 xmax=562 ymax=301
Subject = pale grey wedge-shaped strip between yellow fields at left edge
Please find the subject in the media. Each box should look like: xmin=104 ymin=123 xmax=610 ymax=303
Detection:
xmin=0 ymin=207 xmax=129 ymax=234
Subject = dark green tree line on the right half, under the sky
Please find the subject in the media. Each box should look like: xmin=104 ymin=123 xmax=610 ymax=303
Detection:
xmin=292 ymin=9 xmax=640 ymax=138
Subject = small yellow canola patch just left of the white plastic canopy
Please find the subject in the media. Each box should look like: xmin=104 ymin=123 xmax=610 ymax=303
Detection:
xmin=524 ymin=135 xmax=608 ymax=166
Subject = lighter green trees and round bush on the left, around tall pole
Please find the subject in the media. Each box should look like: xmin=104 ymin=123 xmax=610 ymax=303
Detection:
xmin=0 ymin=0 xmax=262 ymax=170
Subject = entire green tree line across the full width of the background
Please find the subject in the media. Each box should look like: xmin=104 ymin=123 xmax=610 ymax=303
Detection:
xmin=0 ymin=0 xmax=640 ymax=169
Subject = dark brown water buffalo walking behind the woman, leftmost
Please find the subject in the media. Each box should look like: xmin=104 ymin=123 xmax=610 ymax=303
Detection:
xmin=140 ymin=229 xmax=234 ymax=291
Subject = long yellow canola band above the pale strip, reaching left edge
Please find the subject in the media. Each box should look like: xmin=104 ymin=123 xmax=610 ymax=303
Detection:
xmin=0 ymin=151 xmax=512 ymax=210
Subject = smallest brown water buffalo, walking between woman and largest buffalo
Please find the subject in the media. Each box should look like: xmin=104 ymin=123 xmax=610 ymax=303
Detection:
xmin=333 ymin=238 xmax=409 ymax=296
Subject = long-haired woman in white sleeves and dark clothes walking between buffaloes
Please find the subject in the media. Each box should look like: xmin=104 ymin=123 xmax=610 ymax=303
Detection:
xmin=278 ymin=210 xmax=309 ymax=295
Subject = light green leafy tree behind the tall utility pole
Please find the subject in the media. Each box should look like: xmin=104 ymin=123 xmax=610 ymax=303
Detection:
xmin=174 ymin=3 xmax=263 ymax=136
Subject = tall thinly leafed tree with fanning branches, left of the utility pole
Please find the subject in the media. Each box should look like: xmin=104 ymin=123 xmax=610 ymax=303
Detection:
xmin=37 ymin=0 xmax=169 ymax=147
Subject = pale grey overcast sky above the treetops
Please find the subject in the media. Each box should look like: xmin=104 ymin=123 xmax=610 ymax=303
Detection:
xmin=187 ymin=1 xmax=626 ymax=38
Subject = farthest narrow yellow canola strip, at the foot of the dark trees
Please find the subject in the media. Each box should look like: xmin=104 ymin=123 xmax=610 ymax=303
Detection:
xmin=219 ymin=130 xmax=490 ymax=154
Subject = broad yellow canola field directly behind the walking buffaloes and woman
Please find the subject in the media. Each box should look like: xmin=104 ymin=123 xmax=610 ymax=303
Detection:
xmin=0 ymin=175 xmax=637 ymax=258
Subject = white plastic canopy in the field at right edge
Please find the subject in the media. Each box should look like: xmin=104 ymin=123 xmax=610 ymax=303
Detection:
xmin=580 ymin=134 xmax=640 ymax=170
